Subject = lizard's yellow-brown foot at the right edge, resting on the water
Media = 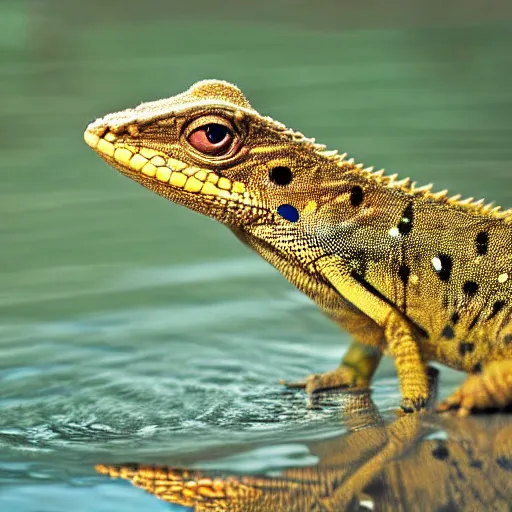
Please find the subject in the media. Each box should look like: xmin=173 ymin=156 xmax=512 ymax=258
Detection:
xmin=437 ymin=361 xmax=512 ymax=416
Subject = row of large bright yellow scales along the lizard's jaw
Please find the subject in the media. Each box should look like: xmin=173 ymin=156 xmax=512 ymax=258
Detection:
xmin=84 ymin=128 xmax=248 ymax=200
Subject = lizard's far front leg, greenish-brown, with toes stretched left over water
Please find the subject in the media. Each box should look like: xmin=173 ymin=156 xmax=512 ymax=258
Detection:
xmin=281 ymin=340 xmax=382 ymax=394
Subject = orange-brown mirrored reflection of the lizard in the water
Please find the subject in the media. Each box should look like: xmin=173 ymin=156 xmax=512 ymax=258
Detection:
xmin=96 ymin=384 xmax=512 ymax=512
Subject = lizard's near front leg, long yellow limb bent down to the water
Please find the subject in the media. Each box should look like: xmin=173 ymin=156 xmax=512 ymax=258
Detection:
xmin=315 ymin=255 xmax=428 ymax=412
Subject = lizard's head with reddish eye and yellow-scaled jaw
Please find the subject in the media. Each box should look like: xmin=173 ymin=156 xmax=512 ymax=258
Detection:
xmin=84 ymin=80 xmax=354 ymax=266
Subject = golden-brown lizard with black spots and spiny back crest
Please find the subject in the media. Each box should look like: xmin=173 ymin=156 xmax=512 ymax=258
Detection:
xmin=84 ymin=80 xmax=512 ymax=415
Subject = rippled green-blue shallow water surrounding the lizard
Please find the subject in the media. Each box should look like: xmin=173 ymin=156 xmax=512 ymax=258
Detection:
xmin=0 ymin=0 xmax=512 ymax=512
